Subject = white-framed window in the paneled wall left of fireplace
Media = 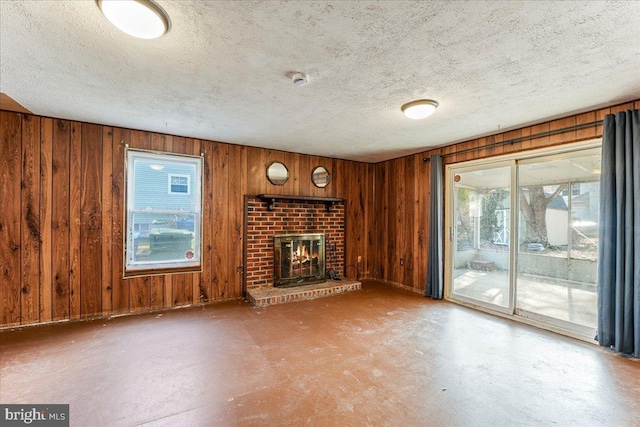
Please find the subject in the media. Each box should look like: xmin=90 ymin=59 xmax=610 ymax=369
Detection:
xmin=124 ymin=148 xmax=202 ymax=276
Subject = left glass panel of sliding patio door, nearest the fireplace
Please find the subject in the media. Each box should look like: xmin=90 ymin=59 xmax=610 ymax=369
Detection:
xmin=449 ymin=162 xmax=513 ymax=312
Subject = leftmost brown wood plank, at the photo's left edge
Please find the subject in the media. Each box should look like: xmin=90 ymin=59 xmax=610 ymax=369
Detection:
xmin=0 ymin=111 xmax=23 ymax=326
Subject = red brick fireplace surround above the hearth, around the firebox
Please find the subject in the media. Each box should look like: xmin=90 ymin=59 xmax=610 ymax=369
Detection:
xmin=244 ymin=195 xmax=345 ymax=291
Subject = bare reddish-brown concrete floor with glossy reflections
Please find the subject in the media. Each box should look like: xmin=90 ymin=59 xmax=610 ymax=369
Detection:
xmin=0 ymin=281 xmax=640 ymax=426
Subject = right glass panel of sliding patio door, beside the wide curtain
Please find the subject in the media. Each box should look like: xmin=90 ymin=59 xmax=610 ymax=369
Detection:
xmin=516 ymin=149 xmax=600 ymax=335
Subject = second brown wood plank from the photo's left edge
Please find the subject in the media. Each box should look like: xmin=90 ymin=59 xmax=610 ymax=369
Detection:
xmin=20 ymin=115 xmax=41 ymax=324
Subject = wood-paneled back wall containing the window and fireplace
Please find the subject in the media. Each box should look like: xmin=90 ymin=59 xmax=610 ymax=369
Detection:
xmin=0 ymin=111 xmax=375 ymax=327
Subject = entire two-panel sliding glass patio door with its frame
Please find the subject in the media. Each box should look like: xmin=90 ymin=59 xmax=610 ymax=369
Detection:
xmin=446 ymin=144 xmax=600 ymax=337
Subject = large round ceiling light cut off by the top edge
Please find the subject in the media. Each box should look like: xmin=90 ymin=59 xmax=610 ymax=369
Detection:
xmin=97 ymin=0 xmax=169 ymax=39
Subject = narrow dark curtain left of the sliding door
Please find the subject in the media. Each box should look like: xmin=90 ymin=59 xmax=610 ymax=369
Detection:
xmin=424 ymin=154 xmax=444 ymax=299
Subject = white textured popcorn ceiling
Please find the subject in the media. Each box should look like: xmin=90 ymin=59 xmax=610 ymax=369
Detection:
xmin=0 ymin=0 xmax=640 ymax=162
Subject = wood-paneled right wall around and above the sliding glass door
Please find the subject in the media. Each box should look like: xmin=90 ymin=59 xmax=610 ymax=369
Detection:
xmin=372 ymin=100 xmax=640 ymax=291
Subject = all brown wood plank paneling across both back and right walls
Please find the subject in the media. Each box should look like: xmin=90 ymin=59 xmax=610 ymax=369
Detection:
xmin=0 ymin=101 xmax=640 ymax=327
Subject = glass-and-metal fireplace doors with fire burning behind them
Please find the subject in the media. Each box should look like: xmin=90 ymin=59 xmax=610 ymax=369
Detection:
xmin=273 ymin=233 xmax=325 ymax=286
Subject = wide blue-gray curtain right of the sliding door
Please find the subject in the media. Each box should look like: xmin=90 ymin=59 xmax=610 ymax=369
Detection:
xmin=598 ymin=110 xmax=640 ymax=357
